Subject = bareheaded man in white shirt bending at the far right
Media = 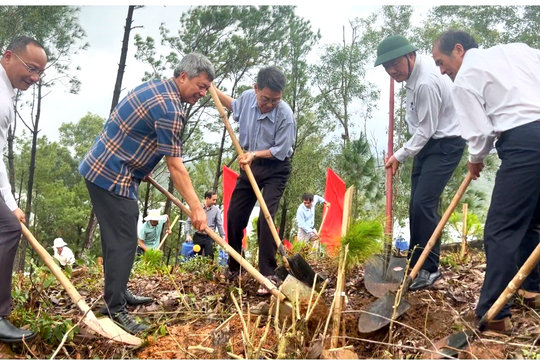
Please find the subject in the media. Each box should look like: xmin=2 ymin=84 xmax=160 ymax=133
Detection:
xmin=433 ymin=30 xmax=540 ymax=331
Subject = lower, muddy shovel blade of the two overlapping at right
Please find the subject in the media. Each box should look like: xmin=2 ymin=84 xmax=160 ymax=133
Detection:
xmin=358 ymin=293 xmax=411 ymax=334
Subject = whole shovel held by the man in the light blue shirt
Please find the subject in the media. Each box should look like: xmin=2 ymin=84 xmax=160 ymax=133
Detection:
xmin=208 ymin=84 xmax=324 ymax=286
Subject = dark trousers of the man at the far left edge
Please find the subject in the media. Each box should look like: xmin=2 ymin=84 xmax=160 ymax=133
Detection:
xmin=0 ymin=197 xmax=22 ymax=317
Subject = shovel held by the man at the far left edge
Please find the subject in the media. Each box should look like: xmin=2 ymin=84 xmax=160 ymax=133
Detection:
xmin=21 ymin=224 xmax=142 ymax=346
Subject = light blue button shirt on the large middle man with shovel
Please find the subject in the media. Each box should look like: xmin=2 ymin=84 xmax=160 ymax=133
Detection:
xmin=231 ymin=89 xmax=296 ymax=161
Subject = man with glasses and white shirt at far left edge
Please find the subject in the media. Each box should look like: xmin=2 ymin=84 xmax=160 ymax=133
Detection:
xmin=0 ymin=36 xmax=47 ymax=343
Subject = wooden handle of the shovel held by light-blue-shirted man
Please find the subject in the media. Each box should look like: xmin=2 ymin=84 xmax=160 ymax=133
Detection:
xmin=208 ymin=83 xmax=289 ymax=267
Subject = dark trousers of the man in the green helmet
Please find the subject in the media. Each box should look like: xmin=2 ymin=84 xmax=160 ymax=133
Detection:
xmin=409 ymin=137 xmax=465 ymax=272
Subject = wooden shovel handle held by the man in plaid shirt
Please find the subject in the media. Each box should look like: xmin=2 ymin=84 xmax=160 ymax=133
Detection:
xmin=146 ymin=176 xmax=285 ymax=301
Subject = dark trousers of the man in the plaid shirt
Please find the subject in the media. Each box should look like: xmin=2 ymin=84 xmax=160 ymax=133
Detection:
xmin=86 ymin=181 xmax=139 ymax=314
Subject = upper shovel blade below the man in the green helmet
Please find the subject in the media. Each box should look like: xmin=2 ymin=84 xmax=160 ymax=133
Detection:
xmin=364 ymin=254 xmax=407 ymax=298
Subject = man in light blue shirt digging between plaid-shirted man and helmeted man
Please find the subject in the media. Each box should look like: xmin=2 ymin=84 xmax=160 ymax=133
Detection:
xmin=213 ymin=66 xmax=296 ymax=295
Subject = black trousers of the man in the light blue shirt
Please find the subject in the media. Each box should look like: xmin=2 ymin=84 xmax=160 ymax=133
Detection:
xmin=227 ymin=159 xmax=291 ymax=276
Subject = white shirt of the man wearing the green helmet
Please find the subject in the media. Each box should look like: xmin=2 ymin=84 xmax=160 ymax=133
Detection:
xmin=394 ymin=55 xmax=460 ymax=163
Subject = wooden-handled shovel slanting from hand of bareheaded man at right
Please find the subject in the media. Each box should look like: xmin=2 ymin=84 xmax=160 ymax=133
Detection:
xmin=358 ymin=172 xmax=472 ymax=334
